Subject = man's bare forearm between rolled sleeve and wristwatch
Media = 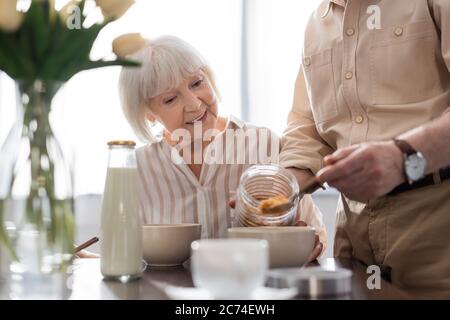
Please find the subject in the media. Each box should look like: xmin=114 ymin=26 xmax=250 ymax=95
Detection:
xmin=398 ymin=109 xmax=450 ymax=173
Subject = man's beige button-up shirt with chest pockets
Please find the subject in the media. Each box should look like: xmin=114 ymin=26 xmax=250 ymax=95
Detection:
xmin=280 ymin=0 xmax=450 ymax=173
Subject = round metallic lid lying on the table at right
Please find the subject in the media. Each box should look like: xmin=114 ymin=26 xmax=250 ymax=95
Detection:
xmin=267 ymin=267 xmax=352 ymax=298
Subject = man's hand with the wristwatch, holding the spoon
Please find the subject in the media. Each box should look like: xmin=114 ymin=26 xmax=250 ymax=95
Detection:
xmin=317 ymin=141 xmax=405 ymax=202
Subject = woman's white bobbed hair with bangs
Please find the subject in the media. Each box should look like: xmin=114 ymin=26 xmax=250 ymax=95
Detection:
xmin=119 ymin=36 xmax=220 ymax=142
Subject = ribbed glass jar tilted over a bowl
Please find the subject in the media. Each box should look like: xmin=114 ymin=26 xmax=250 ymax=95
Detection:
xmin=235 ymin=165 xmax=299 ymax=227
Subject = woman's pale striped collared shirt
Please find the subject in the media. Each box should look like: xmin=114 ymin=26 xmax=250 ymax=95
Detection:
xmin=136 ymin=116 xmax=326 ymax=244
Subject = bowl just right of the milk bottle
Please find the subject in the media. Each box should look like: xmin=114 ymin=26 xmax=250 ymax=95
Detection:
xmin=142 ymin=223 xmax=202 ymax=267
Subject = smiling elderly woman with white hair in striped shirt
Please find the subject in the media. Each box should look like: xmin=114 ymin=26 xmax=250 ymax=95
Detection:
xmin=116 ymin=36 xmax=326 ymax=259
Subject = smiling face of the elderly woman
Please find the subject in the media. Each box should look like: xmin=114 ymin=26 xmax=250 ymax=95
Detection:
xmin=149 ymin=70 xmax=217 ymax=137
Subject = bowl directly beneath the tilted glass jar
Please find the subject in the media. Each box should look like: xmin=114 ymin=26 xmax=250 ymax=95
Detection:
xmin=228 ymin=227 xmax=315 ymax=268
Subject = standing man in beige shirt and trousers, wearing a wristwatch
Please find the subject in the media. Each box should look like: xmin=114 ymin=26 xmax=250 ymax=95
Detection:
xmin=280 ymin=0 xmax=450 ymax=296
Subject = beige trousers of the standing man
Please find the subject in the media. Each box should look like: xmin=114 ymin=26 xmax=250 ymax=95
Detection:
xmin=334 ymin=180 xmax=450 ymax=298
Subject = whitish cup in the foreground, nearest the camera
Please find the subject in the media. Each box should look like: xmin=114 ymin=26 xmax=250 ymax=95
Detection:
xmin=191 ymin=239 xmax=269 ymax=299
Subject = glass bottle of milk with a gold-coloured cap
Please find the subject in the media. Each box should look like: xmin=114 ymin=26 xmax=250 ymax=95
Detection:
xmin=100 ymin=141 xmax=142 ymax=282
